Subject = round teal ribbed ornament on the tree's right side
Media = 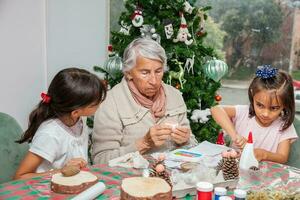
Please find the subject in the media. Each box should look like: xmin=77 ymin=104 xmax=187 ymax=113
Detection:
xmin=204 ymin=58 xmax=228 ymax=82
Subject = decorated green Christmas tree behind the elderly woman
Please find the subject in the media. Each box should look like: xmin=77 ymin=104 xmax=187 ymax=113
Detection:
xmin=94 ymin=0 xmax=227 ymax=143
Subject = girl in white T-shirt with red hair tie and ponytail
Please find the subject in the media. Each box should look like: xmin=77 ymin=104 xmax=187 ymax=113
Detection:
xmin=15 ymin=68 xmax=106 ymax=179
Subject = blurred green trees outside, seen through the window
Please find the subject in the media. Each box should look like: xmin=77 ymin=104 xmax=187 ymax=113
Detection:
xmin=196 ymin=0 xmax=290 ymax=79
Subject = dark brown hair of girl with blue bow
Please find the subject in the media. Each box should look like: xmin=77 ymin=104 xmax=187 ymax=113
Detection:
xmin=248 ymin=70 xmax=295 ymax=131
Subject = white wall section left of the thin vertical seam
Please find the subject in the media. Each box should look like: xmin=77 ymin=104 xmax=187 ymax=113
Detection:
xmin=0 ymin=0 xmax=46 ymax=127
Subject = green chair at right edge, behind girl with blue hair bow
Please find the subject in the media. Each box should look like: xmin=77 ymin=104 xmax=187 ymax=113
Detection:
xmin=287 ymin=119 xmax=300 ymax=168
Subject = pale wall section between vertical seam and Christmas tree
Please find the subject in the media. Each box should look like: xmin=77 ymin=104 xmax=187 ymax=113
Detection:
xmin=47 ymin=0 xmax=109 ymax=80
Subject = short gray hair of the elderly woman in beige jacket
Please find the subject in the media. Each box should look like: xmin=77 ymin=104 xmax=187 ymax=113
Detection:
xmin=122 ymin=38 xmax=167 ymax=73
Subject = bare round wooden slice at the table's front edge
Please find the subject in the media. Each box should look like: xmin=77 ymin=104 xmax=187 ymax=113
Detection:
xmin=121 ymin=177 xmax=172 ymax=200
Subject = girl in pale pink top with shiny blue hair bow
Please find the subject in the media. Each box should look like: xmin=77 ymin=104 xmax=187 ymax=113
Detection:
xmin=211 ymin=65 xmax=298 ymax=163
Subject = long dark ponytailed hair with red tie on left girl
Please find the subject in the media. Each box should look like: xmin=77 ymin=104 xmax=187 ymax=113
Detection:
xmin=16 ymin=68 xmax=106 ymax=143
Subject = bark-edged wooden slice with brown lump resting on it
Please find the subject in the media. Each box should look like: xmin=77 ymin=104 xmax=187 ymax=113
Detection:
xmin=51 ymin=171 xmax=98 ymax=194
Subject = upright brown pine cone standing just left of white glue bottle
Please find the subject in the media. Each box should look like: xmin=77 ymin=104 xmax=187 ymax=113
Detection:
xmin=222 ymin=158 xmax=239 ymax=181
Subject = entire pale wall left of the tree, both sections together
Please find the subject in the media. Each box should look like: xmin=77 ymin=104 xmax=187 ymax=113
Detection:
xmin=0 ymin=0 xmax=108 ymax=129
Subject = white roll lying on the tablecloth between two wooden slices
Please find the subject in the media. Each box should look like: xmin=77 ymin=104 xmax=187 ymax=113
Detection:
xmin=73 ymin=182 xmax=106 ymax=200
